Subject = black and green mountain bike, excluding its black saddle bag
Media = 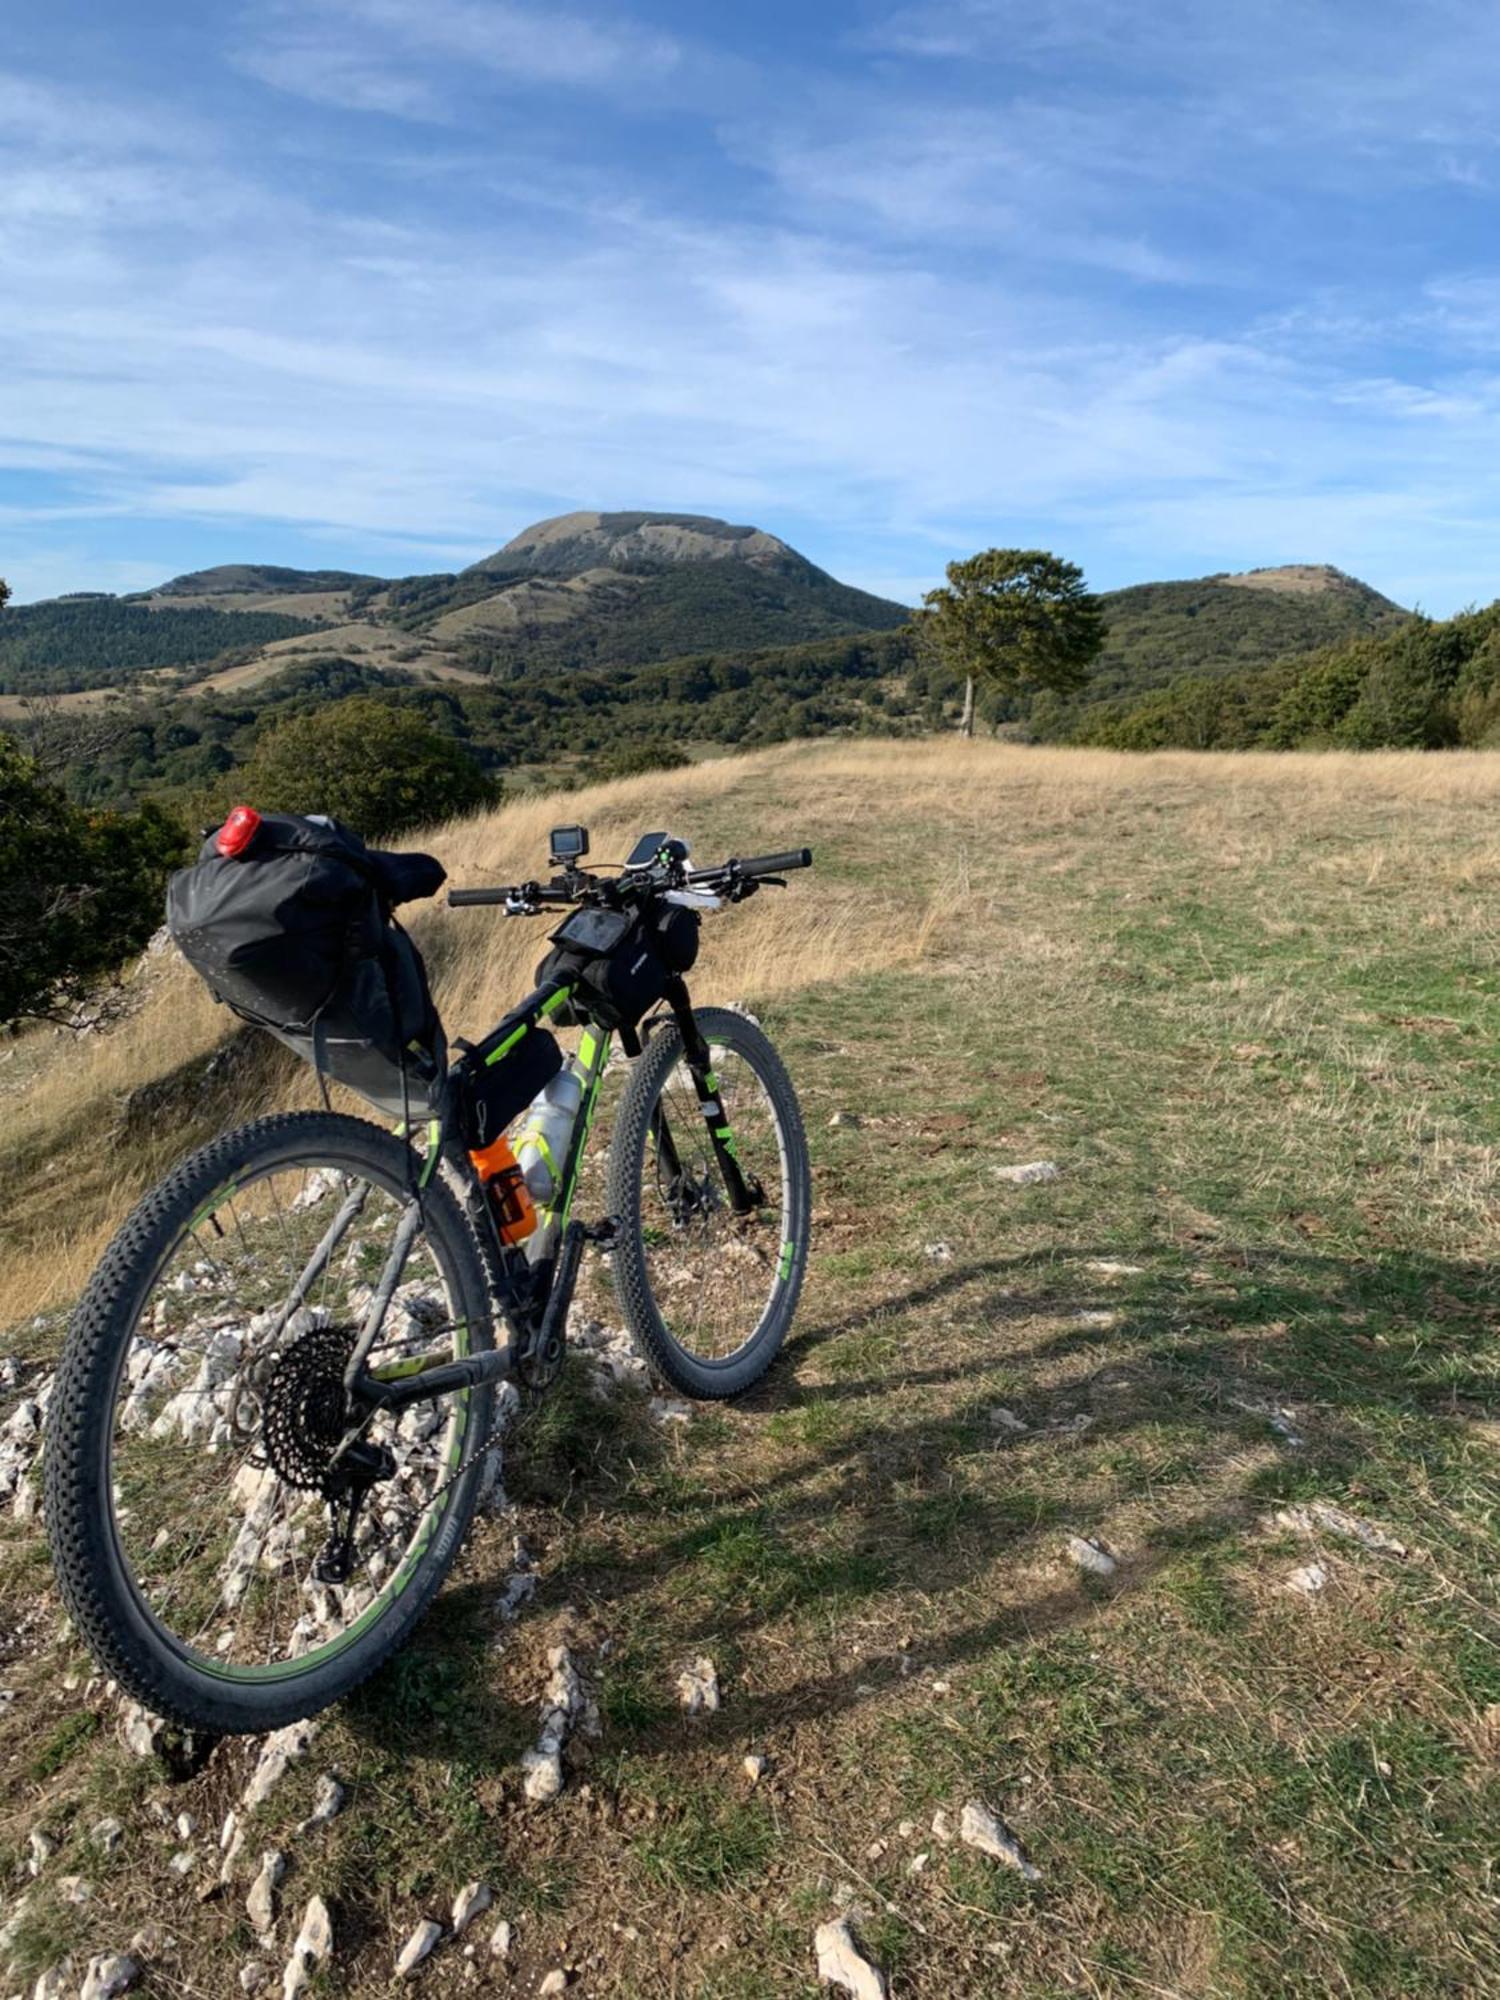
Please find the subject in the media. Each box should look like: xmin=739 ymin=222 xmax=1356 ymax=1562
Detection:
xmin=44 ymin=828 xmax=812 ymax=1734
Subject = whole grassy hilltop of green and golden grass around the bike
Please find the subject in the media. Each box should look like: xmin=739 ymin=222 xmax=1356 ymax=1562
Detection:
xmin=0 ymin=742 xmax=1500 ymax=2000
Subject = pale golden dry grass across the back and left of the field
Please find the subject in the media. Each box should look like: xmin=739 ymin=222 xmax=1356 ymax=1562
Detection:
xmin=0 ymin=738 xmax=1500 ymax=1324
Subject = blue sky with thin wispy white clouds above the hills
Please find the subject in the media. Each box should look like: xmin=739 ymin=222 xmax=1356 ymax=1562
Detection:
xmin=0 ymin=0 xmax=1500 ymax=614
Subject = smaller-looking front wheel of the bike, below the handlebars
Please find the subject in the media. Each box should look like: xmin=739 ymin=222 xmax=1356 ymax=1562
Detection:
xmin=608 ymin=1008 xmax=812 ymax=1400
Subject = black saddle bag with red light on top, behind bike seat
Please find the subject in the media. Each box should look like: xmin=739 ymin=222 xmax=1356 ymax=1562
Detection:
xmin=166 ymin=812 xmax=448 ymax=1118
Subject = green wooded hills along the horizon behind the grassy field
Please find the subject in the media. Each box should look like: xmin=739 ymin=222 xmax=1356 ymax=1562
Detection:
xmin=0 ymin=512 xmax=1472 ymax=818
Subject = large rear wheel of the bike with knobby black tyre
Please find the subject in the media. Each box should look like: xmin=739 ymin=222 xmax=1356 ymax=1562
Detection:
xmin=46 ymin=1112 xmax=492 ymax=1734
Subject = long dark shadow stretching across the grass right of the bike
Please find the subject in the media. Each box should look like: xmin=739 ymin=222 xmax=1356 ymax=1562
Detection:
xmin=346 ymin=1244 xmax=1496 ymax=1784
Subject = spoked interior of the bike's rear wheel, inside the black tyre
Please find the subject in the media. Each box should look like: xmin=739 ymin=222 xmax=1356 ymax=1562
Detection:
xmin=112 ymin=1168 xmax=466 ymax=1672
